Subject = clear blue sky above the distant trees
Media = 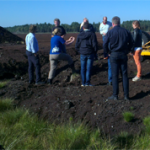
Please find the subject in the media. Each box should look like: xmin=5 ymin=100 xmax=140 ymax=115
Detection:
xmin=0 ymin=0 xmax=150 ymax=27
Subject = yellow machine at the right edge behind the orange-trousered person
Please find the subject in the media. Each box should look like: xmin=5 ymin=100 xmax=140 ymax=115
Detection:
xmin=141 ymin=31 xmax=150 ymax=61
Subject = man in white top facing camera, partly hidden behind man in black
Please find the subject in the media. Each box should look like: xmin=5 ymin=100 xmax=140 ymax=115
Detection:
xmin=99 ymin=17 xmax=112 ymax=85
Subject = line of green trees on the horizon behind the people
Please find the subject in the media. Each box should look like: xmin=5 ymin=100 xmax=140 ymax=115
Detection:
xmin=5 ymin=20 xmax=150 ymax=33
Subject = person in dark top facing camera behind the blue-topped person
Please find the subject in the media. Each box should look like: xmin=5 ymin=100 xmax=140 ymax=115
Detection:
xmin=52 ymin=18 xmax=66 ymax=53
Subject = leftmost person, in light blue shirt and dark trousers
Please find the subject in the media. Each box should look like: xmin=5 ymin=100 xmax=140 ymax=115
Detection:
xmin=25 ymin=25 xmax=44 ymax=85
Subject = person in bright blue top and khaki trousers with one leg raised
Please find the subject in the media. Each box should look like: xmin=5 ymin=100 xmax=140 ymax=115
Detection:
xmin=48 ymin=28 xmax=76 ymax=84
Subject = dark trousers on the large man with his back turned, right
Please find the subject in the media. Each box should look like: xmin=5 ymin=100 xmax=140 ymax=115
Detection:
xmin=110 ymin=55 xmax=129 ymax=97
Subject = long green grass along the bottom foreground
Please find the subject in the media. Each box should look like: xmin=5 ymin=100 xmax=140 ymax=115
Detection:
xmin=0 ymin=99 xmax=150 ymax=150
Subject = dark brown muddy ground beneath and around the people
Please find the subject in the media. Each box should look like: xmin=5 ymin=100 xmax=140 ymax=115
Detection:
xmin=0 ymin=33 xmax=150 ymax=136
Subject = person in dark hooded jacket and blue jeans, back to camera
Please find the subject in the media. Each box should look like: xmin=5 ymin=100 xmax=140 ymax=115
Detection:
xmin=75 ymin=22 xmax=97 ymax=86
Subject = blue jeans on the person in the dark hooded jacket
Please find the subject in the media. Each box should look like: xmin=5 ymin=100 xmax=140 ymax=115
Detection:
xmin=80 ymin=54 xmax=94 ymax=85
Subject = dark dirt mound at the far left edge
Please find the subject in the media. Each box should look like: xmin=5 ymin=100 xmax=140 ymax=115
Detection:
xmin=0 ymin=26 xmax=24 ymax=44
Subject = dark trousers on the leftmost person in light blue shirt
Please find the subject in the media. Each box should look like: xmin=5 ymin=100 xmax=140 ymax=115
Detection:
xmin=26 ymin=51 xmax=41 ymax=82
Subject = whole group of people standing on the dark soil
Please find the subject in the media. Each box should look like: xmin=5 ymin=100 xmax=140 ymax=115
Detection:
xmin=25 ymin=17 xmax=142 ymax=100
